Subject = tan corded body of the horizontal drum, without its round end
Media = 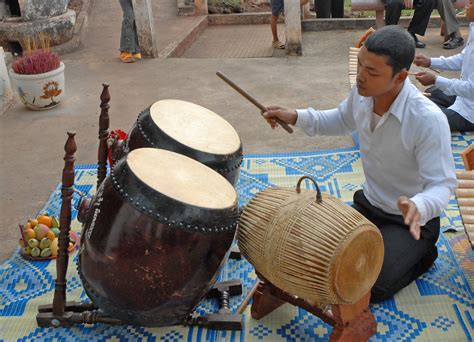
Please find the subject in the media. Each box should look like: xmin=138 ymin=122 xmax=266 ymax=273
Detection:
xmin=238 ymin=188 xmax=373 ymax=305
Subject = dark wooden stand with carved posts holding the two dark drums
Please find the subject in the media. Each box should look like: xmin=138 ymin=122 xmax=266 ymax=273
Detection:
xmin=36 ymin=93 xmax=242 ymax=330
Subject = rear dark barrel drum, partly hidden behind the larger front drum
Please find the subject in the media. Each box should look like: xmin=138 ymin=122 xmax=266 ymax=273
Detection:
xmin=113 ymin=99 xmax=242 ymax=185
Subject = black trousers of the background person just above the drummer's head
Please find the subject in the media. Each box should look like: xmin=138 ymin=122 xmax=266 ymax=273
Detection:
xmin=382 ymin=0 xmax=437 ymax=36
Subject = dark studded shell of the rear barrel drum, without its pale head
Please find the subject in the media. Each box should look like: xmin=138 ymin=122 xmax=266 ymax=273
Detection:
xmin=114 ymin=100 xmax=243 ymax=185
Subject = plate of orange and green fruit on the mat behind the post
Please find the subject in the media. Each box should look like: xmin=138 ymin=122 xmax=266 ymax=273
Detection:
xmin=19 ymin=214 xmax=79 ymax=260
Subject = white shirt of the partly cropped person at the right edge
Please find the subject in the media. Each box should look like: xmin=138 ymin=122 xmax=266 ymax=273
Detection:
xmin=431 ymin=23 xmax=474 ymax=123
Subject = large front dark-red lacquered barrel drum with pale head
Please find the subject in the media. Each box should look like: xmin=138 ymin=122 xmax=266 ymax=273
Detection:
xmin=79 ymin=148 xmax=238 ymax=326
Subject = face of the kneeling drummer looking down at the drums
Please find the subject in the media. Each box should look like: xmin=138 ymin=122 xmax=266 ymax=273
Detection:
xmin=357 ymin=46 xmax=403 ymax=96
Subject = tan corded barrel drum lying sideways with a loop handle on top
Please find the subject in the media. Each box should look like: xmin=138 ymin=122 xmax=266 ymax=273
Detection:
xmin=237 ymin=177 xmax=384 ymax=304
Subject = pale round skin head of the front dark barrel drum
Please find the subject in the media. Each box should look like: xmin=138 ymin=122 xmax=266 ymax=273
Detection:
xmin=127 ymin=148 xmax=237 ymax=209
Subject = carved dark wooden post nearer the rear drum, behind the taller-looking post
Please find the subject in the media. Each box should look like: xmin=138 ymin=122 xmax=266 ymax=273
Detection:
xmin=97 ymin=83 xmax=110 ymax=188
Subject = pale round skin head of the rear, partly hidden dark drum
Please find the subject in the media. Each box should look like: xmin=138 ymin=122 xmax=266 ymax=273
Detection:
xmin=150 ymin=100 xmax=240 ymax=155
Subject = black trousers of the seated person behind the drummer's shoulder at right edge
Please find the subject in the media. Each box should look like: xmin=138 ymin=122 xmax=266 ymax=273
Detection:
xmin=426 ymin=86 xmax=474 ymax=132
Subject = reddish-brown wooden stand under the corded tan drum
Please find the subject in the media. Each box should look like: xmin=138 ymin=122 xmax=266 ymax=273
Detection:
xmin=251 ymin=275 xmax=377 ymax=342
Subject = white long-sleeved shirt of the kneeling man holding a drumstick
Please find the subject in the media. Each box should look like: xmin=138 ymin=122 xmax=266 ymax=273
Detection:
xmin=295 ymin=79 xmax=457 ymax=225
